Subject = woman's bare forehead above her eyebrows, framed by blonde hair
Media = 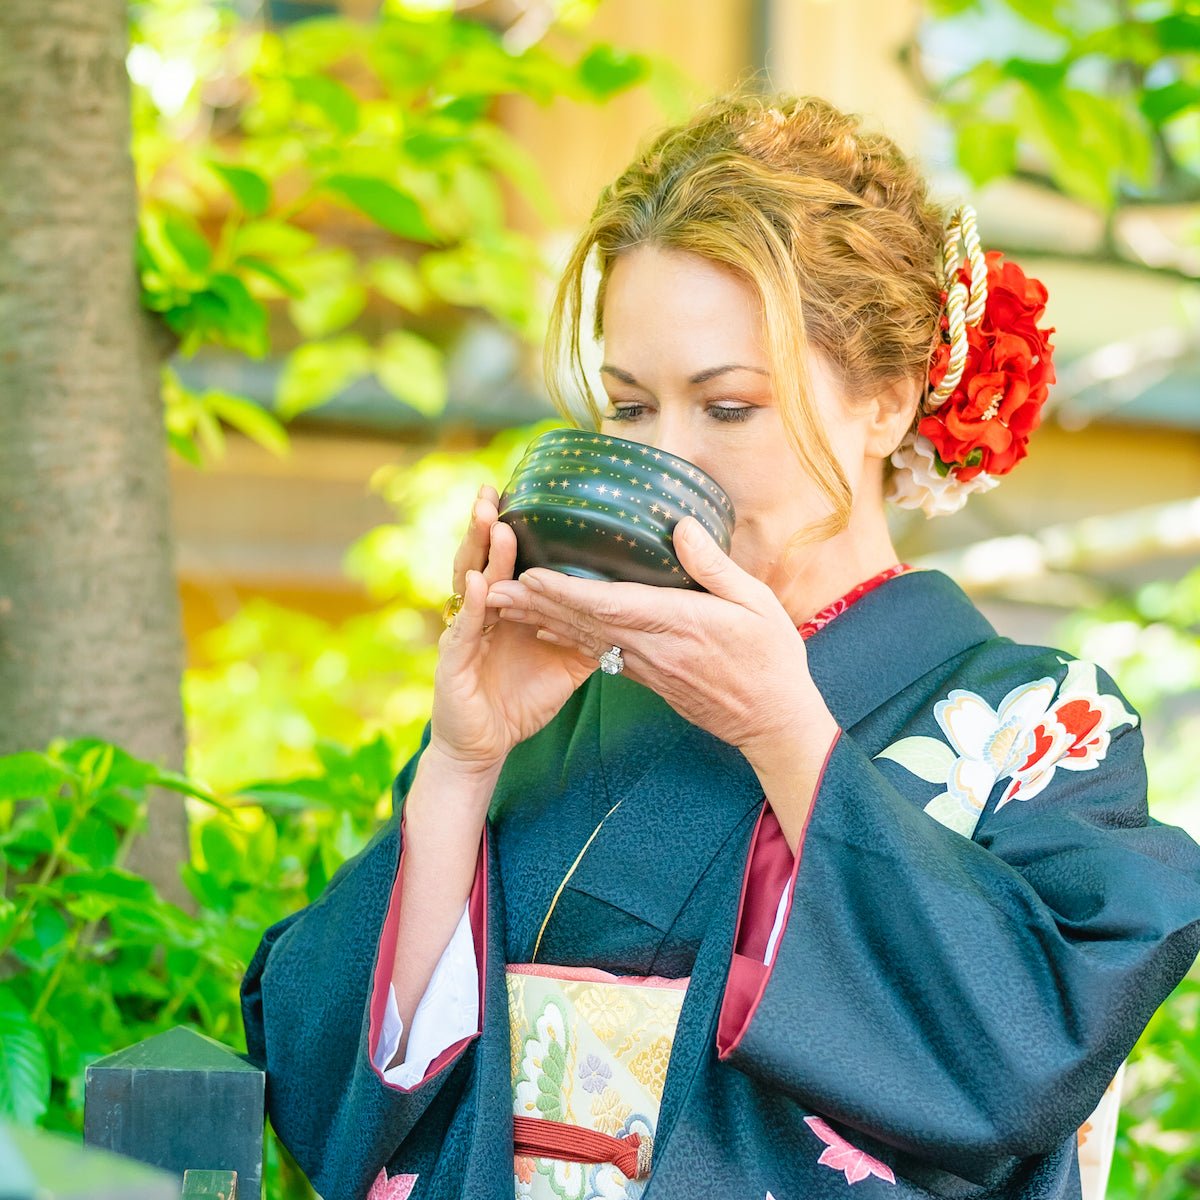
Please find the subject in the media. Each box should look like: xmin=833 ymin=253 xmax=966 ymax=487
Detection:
xmin=604 ymin=246 xmax=767 ymax=373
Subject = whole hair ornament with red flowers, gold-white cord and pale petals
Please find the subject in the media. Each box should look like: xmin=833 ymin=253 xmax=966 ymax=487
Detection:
xmin=887 ymin=204 xmax=1055 ymax=517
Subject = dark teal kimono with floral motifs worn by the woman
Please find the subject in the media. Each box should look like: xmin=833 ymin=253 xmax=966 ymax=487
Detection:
xmin=242 ymin=571 xmax=1200 ymax=1200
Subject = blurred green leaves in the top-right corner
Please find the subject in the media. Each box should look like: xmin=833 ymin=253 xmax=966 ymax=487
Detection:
xmin=930 ymin=0 xmax=1200 ymax=211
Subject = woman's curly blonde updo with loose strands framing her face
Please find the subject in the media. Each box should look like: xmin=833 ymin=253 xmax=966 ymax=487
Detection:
xmin=545 ymin=86 xmax=944 ymax=541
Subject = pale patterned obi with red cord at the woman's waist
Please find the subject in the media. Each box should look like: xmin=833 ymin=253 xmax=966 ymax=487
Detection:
xmin=506 ymin=962 xmax=689 ymax=1200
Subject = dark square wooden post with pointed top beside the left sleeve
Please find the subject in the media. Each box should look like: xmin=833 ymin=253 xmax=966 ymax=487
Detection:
xmin=84 ymin=1026 xmax=266 ymax=1200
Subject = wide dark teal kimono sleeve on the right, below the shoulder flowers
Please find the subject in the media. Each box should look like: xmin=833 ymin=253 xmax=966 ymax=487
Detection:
xmin=718 ymin=668 xmax=1200 ymax=1176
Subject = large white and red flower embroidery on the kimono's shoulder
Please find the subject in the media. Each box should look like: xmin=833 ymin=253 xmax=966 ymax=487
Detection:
xmin=876 ymin=659 xmax=1138 ymax=838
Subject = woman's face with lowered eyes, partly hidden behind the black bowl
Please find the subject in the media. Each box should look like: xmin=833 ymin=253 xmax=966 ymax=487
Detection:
xmin=601 ymin=246 xmax=906 ymax=608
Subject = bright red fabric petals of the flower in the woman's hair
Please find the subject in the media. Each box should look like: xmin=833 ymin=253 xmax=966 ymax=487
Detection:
xmin=918 ymin=250 xmax=1055 ymax=481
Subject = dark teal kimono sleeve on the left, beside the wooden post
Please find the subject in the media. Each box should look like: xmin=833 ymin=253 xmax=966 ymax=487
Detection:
xmin=241 ymin=726 xmax=487 ymax=1200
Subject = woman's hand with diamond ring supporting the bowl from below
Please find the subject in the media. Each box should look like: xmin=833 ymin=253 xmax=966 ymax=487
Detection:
xmin=487 ymin=517 xmax=824 ymax=757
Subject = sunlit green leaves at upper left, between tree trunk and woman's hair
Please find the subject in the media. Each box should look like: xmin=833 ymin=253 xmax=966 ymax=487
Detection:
xmin=130 ymin=0 xmax=678 ymax=463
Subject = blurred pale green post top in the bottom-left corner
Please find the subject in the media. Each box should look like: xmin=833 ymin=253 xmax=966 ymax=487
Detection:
xmin=0 ymin=1122 xmax=179 ymax=1200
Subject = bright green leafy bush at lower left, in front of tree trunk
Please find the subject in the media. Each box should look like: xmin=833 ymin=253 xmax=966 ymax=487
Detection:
xmin=0 ymin=737 xmax=396 ymax=1198
